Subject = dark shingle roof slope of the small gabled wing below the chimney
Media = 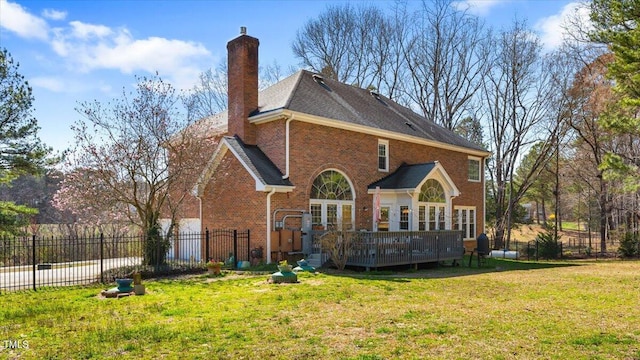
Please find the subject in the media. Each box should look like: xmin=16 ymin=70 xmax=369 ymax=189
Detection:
xmin=224 ymin=136 xmax=293 ymax=186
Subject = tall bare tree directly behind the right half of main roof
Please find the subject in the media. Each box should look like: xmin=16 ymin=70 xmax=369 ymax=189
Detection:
xmin=405 ymin=0 xmax=490 ymax=130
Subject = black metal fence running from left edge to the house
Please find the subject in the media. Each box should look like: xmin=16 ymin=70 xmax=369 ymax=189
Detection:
xmin=0 ymin=230 xmax=251 ymax=292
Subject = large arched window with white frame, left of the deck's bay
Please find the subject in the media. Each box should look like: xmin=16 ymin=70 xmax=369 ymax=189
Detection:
xmin=309 ymin=170 xmax=355 ymax=230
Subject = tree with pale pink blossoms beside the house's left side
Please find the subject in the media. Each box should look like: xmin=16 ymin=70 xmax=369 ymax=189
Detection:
xmin=54 ymin=75 xmax=219 ymax=265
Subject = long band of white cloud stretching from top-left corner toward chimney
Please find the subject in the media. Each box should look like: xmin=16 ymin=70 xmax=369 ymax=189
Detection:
xmin=0 ymin=0 xmax=212 ymax=91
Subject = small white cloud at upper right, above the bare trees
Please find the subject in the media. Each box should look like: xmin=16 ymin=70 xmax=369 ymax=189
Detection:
xmin=534 ymin=2 xmax=589 ymax=50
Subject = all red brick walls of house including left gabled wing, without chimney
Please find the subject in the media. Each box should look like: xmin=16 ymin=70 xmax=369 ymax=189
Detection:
xmin=202 ymin=120 xmax=484 ymax=251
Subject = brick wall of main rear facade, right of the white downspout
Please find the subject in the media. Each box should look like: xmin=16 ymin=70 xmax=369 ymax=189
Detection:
xmin=290 ymin=121 xmax=484 ymax=232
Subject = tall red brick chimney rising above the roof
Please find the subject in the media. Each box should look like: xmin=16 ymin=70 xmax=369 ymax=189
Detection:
xmin=227 ymin=26 xmax=260 ymax=145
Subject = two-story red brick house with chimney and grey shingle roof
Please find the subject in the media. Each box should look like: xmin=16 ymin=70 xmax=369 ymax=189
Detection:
xmin=172 ymin=31 xmax=489 ymax=262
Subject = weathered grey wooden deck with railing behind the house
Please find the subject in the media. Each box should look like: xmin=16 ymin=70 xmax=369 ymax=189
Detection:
xmin=316 ymin=230 xmax=464 ymax=269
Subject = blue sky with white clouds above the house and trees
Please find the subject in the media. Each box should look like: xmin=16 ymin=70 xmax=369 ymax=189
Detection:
xmin=0 ymin=0 xmax=579 ymax=151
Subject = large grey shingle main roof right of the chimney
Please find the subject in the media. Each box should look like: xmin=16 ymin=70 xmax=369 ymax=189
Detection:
xmin=252 ymin=70 xmax=486 ymax=151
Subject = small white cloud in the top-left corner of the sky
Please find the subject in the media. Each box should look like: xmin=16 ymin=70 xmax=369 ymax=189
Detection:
xmin=0 ymin=0 xmax=49 ymax=40
